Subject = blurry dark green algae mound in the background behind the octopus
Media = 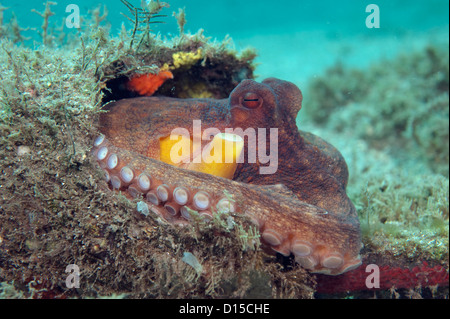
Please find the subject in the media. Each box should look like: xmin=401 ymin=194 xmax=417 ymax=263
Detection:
xmin=304 ymin=44 xmax=449 ymax=175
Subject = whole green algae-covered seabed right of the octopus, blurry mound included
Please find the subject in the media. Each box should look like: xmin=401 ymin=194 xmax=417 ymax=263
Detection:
xmin=304 ymin=44 xmax=449 ymax=298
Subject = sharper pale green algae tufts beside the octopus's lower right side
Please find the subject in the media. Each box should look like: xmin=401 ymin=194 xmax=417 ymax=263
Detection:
xmin=354 ymin=174 xmax=449 ymax=263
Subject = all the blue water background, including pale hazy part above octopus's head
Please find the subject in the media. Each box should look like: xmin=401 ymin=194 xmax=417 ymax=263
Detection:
xmin=0 ymin=0 xmax=449 ymax=86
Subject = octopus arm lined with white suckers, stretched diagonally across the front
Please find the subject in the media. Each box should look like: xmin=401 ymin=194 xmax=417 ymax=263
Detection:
xmin=93 ymin=137 xmax=361 ymax=275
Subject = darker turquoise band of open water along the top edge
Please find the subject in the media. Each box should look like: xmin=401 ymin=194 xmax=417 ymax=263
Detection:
xmin=1 ymin=0 xmax=449 ymax=38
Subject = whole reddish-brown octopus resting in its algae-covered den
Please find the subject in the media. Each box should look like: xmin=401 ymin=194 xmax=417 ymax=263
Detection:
xmin=93 ymin=78 xmax=362 ymax=275
